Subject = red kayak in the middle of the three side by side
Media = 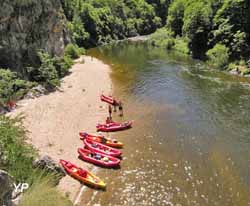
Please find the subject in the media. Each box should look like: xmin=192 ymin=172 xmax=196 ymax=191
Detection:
xmin=83 ymin=139 xmax=122 ymax=157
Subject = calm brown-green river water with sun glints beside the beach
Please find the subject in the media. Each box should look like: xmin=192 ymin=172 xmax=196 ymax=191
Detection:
xmin=79 ymin=42 xmax=250 ymax=206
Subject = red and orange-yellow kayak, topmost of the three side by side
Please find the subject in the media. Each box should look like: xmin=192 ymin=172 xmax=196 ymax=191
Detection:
xmin=79 ymin=132 xmax=123 ymax=148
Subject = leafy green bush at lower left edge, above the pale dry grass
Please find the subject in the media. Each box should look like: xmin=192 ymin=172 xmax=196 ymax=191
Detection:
xmin=0 ymin=115 xmax=36 ymax=182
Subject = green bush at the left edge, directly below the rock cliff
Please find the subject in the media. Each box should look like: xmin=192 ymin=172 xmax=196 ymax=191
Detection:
xmin=0 ymin=69 xmax=33 ymax=103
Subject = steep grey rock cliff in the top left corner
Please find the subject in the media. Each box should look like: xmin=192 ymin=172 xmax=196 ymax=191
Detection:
xmin=0 ymin=0 xmax=70 ymax=74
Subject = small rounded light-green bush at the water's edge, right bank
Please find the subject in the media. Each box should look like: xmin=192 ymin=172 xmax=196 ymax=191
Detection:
xmin=206 ymin=44 xmax=229 ymax=70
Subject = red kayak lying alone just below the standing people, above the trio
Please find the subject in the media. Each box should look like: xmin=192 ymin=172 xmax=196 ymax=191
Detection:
xmin=96 ymin=121 xmax=132 ymax=132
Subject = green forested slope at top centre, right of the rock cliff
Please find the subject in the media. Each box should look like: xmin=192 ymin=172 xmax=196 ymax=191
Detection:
xmin=61 ymin=0 xmax=168 ymax=47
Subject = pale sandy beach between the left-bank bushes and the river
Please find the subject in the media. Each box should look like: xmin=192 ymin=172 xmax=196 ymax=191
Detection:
xmin=10 ymin=57 xmax=111 ymax=201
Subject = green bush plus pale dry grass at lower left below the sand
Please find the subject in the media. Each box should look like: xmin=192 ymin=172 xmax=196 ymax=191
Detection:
xmin=0 ymin=115 xmax=72 ymax=206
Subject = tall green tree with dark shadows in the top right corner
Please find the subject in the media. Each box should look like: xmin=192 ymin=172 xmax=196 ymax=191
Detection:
xmin=211 ymin=0 xmax=250 ymax=59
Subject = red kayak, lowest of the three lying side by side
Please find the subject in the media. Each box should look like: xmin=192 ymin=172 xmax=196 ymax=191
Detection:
xmin=77 ymin=148 xmax=120 ymax=167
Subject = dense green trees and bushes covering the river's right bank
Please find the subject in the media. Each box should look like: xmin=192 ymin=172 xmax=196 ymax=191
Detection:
xmin=150 ymin=0 xmax=250 ymax=72
